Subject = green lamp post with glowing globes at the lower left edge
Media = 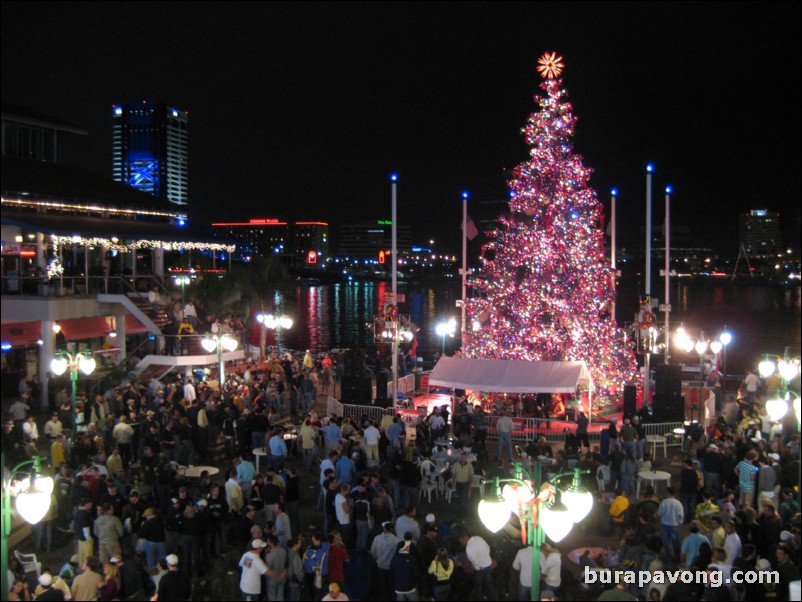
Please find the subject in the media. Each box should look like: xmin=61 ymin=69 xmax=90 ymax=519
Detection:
xmin=0 ymin=454 xmax=53 ymax=599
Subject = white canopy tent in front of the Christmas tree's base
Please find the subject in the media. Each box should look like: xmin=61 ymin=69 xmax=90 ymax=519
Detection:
xmin=429 ymin=357 xmax=593 ymax=418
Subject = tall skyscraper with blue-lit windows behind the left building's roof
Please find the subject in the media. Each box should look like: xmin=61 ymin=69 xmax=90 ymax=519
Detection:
xmin=112 ymin=102 xmax=189 ymax=206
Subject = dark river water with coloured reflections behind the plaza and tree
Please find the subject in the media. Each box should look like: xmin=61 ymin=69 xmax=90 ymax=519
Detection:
xmin=282 ymin=277 xmax=802 ymax=373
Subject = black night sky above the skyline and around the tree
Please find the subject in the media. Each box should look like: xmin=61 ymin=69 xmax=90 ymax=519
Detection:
xmin=2 ymin=2 xmax=802 ymax=253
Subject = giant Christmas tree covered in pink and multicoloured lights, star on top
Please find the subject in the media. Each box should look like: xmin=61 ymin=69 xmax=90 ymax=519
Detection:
xmin=464 ymin=53 xmax=638 ymax=393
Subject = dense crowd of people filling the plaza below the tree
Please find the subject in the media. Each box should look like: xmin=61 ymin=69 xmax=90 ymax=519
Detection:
xmin=3 ymin=353 xmax=800 ymax=600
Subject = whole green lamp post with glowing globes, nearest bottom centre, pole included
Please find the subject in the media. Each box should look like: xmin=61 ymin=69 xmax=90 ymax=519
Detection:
xmin=478 ymin=460 xmax=593 ymax=600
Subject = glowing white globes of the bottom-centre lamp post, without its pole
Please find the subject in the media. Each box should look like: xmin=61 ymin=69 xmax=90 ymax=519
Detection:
xmin=478 ymin=472 xmax=593 ymax=542
